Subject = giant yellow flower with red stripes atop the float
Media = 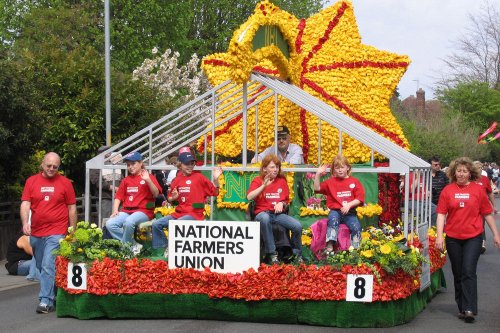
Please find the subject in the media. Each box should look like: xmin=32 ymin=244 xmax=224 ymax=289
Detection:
xmin=199 ymin=0 xmax=410 ymax=163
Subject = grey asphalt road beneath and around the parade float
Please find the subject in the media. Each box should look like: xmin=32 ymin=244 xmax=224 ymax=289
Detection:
xmin=0 ymin=198 xmax=500 ymax=333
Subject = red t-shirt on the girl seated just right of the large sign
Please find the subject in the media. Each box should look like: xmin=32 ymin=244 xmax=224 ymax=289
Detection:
xmin=247 ymin=176 xmax=290 ymax=214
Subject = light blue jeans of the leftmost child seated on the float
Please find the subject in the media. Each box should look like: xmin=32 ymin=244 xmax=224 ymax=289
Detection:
xmin=106 ymin=212 xmax=149 ymax=243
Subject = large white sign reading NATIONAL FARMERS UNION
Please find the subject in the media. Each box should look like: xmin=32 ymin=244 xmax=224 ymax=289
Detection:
xmin=168 ymin=220 xmax=260 ymax=273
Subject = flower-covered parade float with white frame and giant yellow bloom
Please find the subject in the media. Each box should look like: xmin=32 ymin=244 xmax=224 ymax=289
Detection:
xmin=73 ymin=1 xmax=445 ymax=327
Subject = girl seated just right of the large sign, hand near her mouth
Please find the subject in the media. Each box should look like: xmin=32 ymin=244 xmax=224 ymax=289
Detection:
xmin=247 ymin=154 xmax=302 ymax=265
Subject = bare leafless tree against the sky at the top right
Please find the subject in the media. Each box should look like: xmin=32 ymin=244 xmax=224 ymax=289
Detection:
xmin=438 ymin=2 xmax=500 ymax=90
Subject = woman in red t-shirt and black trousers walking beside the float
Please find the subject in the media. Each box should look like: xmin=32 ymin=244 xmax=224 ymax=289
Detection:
xmin=436 ymin=157 xmax=500 ymax=323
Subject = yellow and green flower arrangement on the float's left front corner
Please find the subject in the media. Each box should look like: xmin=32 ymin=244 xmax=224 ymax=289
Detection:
xmin=54 ymin=221 xmax=134 ymax=262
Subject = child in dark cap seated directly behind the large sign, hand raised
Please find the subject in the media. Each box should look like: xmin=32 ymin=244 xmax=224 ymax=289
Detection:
xmin=152 ymin=147 xmax=222 ymax=258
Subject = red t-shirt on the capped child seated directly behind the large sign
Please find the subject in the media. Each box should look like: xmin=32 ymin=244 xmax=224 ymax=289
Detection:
xmin=168 ymin=172 xmax=218 ymax=220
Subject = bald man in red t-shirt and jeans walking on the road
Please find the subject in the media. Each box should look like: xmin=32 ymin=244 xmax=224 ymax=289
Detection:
xmin=20 ymin=152 xmax=77 ymax=313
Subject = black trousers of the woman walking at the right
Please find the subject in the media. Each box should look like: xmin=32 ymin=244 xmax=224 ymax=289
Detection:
xmin=446 ymin=234 xmax=483 ymax=314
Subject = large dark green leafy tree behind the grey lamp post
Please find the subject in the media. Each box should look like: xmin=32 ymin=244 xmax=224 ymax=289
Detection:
xmin=14 ymin=6 xmax=172 ymax=189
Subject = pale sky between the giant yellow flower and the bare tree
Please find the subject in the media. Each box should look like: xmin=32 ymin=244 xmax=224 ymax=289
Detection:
xmin=329 ymin=0 xmax=494 ymax=100
